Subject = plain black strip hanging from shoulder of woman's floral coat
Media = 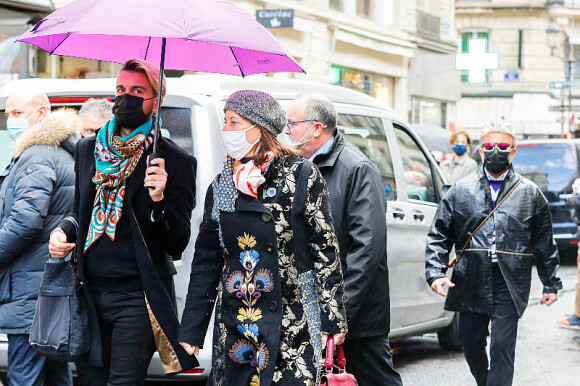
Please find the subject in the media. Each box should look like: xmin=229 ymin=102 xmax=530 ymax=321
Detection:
xmin=291 ymin=160 xmax=312 ymax=274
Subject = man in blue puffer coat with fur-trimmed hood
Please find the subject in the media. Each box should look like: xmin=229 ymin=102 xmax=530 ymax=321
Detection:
xmin=0 ymin=90 xmax=81 ymax=386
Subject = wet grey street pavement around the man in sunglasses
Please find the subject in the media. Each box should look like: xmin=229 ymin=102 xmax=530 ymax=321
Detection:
xmin=394 ymin=266 xmax=580 ymax=386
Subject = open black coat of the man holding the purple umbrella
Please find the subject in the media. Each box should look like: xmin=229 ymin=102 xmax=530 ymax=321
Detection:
xmin=61 ymin=130 xmax=197 ymax=374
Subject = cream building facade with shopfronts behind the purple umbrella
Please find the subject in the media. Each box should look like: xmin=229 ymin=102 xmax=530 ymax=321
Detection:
xmin=0 ymin=0 xmax=460 ymax=127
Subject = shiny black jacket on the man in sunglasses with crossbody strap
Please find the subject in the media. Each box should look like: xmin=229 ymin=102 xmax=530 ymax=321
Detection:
xmin=425 ymin=166 xmax=562 ymax=317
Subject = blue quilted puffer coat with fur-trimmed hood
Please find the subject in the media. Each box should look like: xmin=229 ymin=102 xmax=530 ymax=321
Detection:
xmin=0 ymin=112 xmax=80 ymax=334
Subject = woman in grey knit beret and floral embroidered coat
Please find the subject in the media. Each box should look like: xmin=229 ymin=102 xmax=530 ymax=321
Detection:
xmin=179 ymin=90 xmax=346 ymax=386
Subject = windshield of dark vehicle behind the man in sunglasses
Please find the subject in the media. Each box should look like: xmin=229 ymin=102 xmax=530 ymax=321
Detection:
xmin=513 ymin=142 xmax=578 ymax=201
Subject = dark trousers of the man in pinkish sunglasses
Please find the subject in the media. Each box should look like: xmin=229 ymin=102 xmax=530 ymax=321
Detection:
xmin=459 ymin=267 xmax=519 ymax=386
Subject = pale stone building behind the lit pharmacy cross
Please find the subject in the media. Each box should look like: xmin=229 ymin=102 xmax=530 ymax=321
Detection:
xmin=455 ymin=0 xmax=580 ymax=137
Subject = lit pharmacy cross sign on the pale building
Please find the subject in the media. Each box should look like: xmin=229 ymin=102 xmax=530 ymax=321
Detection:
xmin=455 ymin=39 xmax=499 ymax=83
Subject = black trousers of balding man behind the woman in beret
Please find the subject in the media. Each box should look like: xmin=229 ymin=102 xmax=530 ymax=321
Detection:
xmin=344 ymin=335 xmax=403 ymax=386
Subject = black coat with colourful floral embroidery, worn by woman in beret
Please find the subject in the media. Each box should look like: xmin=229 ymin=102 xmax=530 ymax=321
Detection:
xmin=179 ymin=157 xmax=346 ymax=386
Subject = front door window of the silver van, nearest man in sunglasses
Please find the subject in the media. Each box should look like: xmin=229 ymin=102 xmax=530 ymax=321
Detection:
xmin=393 ymin=125 xmax=437 ymax=202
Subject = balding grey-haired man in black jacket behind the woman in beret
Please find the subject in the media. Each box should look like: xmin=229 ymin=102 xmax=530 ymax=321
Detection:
xmin=285 ymin=94 xmax=402 ymax=386
